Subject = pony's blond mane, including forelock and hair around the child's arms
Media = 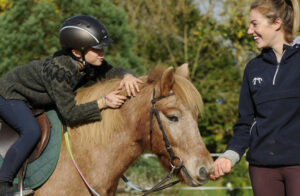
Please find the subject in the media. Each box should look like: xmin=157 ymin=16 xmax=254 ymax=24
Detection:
xmin=69 ymin=67 xmax=203 ymax=144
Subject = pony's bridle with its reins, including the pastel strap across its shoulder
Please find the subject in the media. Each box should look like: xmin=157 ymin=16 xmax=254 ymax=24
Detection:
xmin=63 ymin=89 xmax=184 ymax=196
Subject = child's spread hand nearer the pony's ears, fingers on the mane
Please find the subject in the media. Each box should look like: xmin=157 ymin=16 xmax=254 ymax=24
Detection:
xmin=118 ymin=74 xmax=144 ymax=96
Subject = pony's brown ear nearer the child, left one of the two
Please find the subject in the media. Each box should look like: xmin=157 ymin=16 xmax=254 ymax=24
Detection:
xmin=160 ymin=67 xmax=175 ymax=96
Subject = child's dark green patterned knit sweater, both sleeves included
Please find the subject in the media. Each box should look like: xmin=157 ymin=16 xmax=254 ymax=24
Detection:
xmin=0 ymin=52 xmax=132 ymax=125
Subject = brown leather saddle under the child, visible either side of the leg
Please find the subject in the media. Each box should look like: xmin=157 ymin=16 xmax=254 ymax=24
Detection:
xmin=0 ymin=110 xmax=51 ymax=185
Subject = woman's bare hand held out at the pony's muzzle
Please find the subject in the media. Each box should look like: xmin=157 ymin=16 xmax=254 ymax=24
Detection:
xmin=209 ymin=157 xmax=232 ymax=180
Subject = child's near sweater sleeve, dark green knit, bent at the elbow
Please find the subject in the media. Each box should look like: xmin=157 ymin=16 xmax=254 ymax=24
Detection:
xmin=43 ymin=57 xmax=101 ymax=126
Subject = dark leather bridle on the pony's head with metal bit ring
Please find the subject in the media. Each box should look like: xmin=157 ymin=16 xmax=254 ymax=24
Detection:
xmin=138 ymin=89 xmax=183 ymax=196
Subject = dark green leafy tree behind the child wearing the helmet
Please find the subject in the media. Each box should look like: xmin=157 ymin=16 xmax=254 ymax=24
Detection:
xmin=0 ymin=0 xmax=144 ymax=75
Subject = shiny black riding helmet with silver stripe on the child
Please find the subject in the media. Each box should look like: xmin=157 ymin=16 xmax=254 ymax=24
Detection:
xmin=59 ymin=15 xmax=112 ymax=51
